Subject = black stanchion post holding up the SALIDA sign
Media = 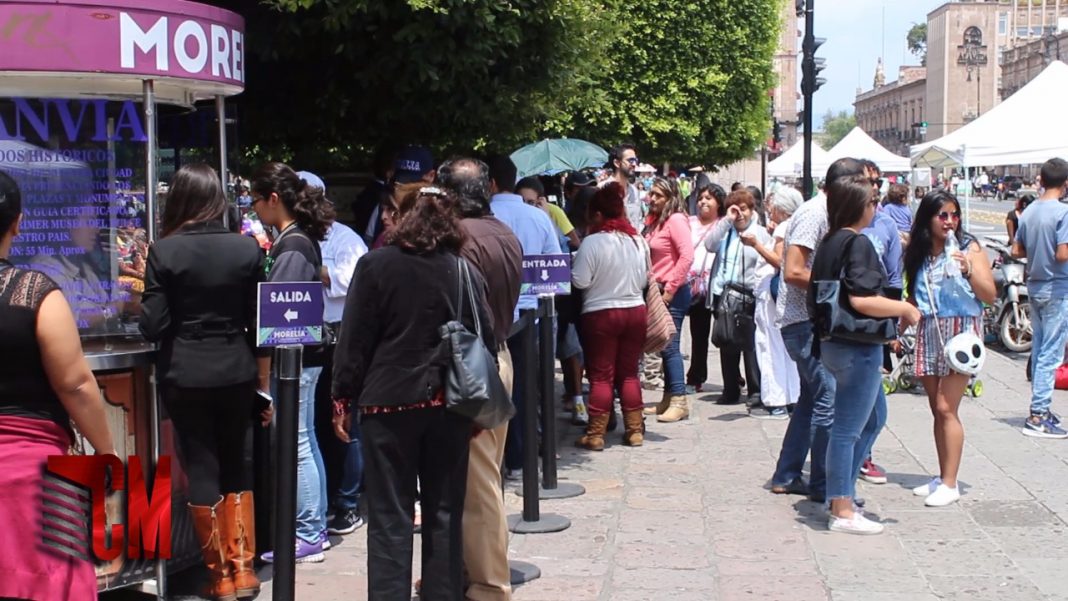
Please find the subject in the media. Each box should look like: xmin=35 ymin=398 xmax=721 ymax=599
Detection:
xmin=271 ymin=345 xmax=304 ymax=601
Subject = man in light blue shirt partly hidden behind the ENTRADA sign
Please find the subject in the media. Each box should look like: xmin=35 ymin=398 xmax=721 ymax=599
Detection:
xmin=489 ymin=156 xmax=561 ymax=480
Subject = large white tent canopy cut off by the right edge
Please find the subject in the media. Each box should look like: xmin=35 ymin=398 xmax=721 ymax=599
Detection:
xmin=911 ymin=61 xmax=1068 ymax=169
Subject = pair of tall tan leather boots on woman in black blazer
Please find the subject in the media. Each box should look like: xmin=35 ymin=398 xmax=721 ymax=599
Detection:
xmin=189 ymin=491 xmax=260 ymax=601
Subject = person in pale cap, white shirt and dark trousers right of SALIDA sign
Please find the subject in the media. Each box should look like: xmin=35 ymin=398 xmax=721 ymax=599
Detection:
xmin=297 ymin=171 xmax=367 ymax=535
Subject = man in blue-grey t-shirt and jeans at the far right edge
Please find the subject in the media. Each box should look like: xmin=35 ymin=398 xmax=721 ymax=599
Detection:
xmin=1012 ymin=154 xmax=1068 ymax=439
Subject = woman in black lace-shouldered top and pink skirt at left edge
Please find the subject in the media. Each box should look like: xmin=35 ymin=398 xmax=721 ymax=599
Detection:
xmin=0 ymin=171 xmax=115 ymax=599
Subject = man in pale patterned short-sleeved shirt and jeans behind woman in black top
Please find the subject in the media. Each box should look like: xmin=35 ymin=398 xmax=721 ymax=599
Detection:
xmin=771 ymin=158 xmax=864 ymax=503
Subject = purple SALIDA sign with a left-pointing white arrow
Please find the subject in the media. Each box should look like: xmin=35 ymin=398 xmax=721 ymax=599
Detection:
xmin=256 ymin=282 xmax=323 ymax=347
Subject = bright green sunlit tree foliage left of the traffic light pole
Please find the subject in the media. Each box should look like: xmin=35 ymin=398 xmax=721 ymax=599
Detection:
xmin=561 ymin=0 xmax=782 ymax=164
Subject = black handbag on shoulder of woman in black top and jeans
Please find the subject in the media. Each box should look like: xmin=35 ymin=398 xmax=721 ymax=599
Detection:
xmin=812 ymin=234 xmax=897 ymax=345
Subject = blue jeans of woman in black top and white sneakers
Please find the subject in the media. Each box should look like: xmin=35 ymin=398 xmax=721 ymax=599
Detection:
xmin=821 ymin=342 xmax=886 ymax=500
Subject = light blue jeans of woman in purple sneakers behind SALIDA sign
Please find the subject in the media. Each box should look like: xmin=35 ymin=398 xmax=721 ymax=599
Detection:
xmin=297 ymin=367 xmax=327 ymax=543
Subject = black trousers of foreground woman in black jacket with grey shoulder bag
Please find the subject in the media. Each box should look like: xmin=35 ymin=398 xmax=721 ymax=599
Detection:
xmin=360 ymin=408 xmax=472 ymax=601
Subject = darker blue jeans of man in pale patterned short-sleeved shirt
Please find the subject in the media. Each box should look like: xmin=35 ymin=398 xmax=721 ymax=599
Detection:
xmin=771 ymin=321 xmax=835 ymax=496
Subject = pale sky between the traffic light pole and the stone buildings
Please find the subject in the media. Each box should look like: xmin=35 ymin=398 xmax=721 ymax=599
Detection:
xmin=811 ymin=0 xmax=945 ymax=121
